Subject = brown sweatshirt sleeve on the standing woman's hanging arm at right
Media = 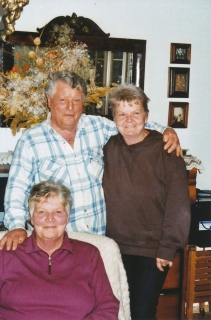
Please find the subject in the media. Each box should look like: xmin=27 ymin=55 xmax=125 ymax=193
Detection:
xmin=157 ymin=150 xmax=191 ymax=261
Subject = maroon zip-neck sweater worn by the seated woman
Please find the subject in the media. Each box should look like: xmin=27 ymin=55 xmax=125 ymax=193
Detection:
xmin=0 ymin=234 xmax=119 ymax=320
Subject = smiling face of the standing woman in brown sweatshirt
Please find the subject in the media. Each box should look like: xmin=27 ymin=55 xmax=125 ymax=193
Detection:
xmin=114 ymin=101 xmax=148 ymax=144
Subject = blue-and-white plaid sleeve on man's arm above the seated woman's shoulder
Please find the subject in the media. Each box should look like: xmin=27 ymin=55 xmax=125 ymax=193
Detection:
xmin=4 ymin=138 xmax=34 ymax=230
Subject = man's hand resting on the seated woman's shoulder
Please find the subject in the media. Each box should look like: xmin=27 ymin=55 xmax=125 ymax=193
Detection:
xmin=0 ymin=229 xmax=27 ymax=251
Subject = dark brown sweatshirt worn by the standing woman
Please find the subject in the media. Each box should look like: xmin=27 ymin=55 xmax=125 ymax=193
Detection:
xmin=103 ymin=130 xmax=190 ymax=261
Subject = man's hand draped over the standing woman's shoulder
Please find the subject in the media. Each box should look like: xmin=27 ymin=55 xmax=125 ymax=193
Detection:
xmin=163 ymin=128 xmax=183 ymax=157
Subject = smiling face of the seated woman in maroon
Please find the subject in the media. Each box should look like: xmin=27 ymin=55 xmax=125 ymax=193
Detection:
xmin=31 ymin=196 xmax=69 ymax=239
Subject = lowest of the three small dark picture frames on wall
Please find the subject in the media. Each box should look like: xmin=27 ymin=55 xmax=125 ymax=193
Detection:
xmin=168 ymin=102 xmax=189 ymax=129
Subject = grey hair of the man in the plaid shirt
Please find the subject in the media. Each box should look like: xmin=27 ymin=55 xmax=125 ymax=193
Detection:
xmin=45 ymin=70 xmax=87 ymax=99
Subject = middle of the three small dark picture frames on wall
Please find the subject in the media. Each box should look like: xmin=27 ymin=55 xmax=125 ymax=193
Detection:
xmin=168 ymin=67 xmax=190 ymax=98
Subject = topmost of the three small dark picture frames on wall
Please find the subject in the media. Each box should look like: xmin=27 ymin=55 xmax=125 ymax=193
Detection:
xmin=170 ymin=43 xmax=191 ymax=64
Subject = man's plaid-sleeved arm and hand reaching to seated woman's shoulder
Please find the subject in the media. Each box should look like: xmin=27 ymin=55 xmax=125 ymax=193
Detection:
xmin=0 ymin=139 xmax=33 ymax=250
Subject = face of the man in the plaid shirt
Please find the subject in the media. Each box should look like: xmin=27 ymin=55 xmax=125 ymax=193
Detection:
xmin=47 ymin=81 xmax=84 ymax=130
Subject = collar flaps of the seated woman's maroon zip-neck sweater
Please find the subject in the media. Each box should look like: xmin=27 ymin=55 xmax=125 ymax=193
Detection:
xmin=25 ymin=230 xmax=73 ymax=253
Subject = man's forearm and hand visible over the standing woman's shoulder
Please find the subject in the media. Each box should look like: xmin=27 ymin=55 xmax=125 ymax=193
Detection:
xmin=145 ymin=122 xmax=183 ymax=157
